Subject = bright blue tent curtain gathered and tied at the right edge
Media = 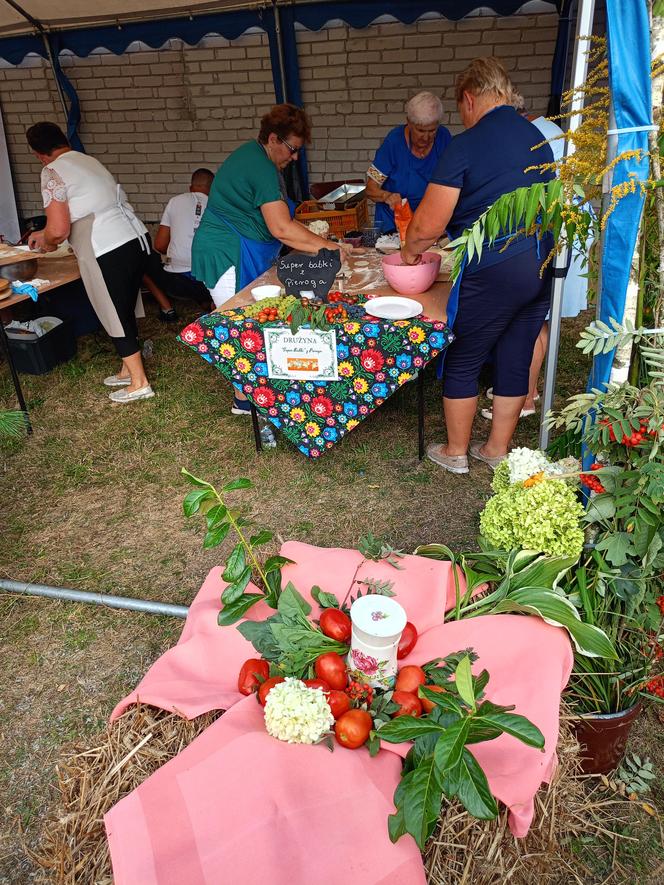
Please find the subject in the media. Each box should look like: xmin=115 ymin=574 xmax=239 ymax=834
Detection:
xmin=589 ymin=0 xmax=652 ymax=389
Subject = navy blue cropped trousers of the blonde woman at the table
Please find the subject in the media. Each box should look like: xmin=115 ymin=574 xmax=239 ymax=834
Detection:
xmin=443 ymin=245 xmax=551 ymax=399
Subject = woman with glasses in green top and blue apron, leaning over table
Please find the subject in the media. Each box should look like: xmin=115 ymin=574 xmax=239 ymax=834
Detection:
xmin=191 ymin=104 xmax=350 ymax=415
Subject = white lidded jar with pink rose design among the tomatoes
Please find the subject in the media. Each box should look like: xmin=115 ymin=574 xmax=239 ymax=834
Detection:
xmin=348 ymin=594 xmax=407 ymax=689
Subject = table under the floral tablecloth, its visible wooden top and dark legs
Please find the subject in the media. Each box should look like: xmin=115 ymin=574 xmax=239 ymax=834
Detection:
xmin=217 ymin=249 xmax=452 ymax=461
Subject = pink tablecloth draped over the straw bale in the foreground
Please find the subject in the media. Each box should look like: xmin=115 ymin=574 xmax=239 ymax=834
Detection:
xmin=105 ymin=542 xmax=572 ymax=885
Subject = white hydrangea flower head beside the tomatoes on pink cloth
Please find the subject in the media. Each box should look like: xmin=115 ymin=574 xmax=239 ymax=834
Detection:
xmin=265 ymin=677 xmax=334 ymax=744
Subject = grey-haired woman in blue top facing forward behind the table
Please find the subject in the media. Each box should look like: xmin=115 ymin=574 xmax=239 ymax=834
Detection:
xmin=367 ymin=92 xmax=452 ymax=231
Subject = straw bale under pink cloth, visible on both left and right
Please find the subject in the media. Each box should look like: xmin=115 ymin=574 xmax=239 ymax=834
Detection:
xmin=26 ymin=705 xmax=640 ymax=885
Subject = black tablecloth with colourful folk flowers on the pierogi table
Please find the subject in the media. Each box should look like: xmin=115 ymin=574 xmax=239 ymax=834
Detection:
xmin=178 ymin=300 xmax=453 ymax=458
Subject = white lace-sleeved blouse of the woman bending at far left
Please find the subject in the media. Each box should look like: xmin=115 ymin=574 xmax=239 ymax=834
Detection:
xmin=41 ymin=151 xmax=147 ymax=258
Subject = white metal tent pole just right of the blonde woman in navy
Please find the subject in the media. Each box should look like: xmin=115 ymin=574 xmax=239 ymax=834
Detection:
xmin=539 ymin=0 xmax=595 ymax=449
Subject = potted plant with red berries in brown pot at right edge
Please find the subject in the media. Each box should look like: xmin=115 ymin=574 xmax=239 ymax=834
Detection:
xmin=550 ymin=342 xmax=664 ymax=773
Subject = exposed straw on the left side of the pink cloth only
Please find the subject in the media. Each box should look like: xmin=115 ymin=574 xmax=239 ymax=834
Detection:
xmin=26 ymin=704 xmax=221 ymax=885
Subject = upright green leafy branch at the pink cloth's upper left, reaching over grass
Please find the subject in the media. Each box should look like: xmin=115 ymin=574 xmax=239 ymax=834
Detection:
xmin=182 ymin=467 xmax=291 ymax=627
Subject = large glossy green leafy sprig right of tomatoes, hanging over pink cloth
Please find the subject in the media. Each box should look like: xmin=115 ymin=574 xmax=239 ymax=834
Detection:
xmin=376 ymin=653 xmax=544 ymax=850
